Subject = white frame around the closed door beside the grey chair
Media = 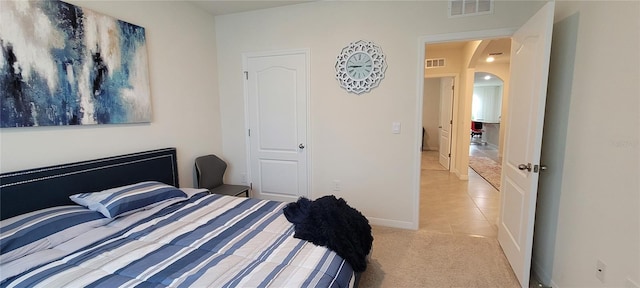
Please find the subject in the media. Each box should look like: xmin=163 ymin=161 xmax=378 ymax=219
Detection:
xmin=242 ymin=48 xmax=313 ymax=197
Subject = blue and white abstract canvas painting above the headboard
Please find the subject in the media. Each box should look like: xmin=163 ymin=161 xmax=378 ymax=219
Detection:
xmin=0 ymin=0 xmax=151 ymax=128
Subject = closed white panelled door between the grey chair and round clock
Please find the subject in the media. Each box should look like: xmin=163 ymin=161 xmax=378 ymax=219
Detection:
xmin=245 ymin=50 xmax=309 ymax=202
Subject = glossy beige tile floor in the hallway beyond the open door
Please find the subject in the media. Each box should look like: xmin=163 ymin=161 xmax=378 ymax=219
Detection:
xmin=420 ymin=151 xmax=500 ymax=238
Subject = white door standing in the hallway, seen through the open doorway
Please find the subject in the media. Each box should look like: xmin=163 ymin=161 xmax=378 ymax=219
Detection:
xmin=438 ymin=77 xmax=454 ymax=170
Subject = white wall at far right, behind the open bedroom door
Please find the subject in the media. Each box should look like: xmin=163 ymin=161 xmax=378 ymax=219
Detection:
xmin=533 ymin=1 xmax=640 ymax=288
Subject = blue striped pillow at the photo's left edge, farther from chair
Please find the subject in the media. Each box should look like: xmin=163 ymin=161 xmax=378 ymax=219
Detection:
xmin=0 ymin=205 xmax=111 ymax=264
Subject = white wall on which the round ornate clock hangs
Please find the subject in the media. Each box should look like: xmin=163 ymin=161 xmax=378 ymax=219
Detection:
xmin=215 ymin=1 xmax=543 ymax=228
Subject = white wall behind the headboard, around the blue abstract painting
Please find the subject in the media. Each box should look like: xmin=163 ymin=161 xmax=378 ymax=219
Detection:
xmin=0 ymin=1 xmax=222 ymax=187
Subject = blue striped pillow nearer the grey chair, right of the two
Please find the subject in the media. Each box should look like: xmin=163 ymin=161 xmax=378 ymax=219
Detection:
xmin=69 ymin=181 xmax=187 ymax=218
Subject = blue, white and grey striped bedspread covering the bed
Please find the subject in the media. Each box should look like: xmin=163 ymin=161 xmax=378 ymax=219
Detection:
xmin=0 ymin=193 xmax=354 ymax=287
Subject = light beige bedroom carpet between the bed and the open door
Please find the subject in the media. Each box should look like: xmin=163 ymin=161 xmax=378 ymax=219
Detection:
xmin=359 ymin=226 xmax=519 ymax=288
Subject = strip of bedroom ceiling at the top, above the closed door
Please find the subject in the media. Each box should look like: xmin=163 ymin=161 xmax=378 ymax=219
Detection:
xmin=187 ymin=0 xmax=316 ymax=16
